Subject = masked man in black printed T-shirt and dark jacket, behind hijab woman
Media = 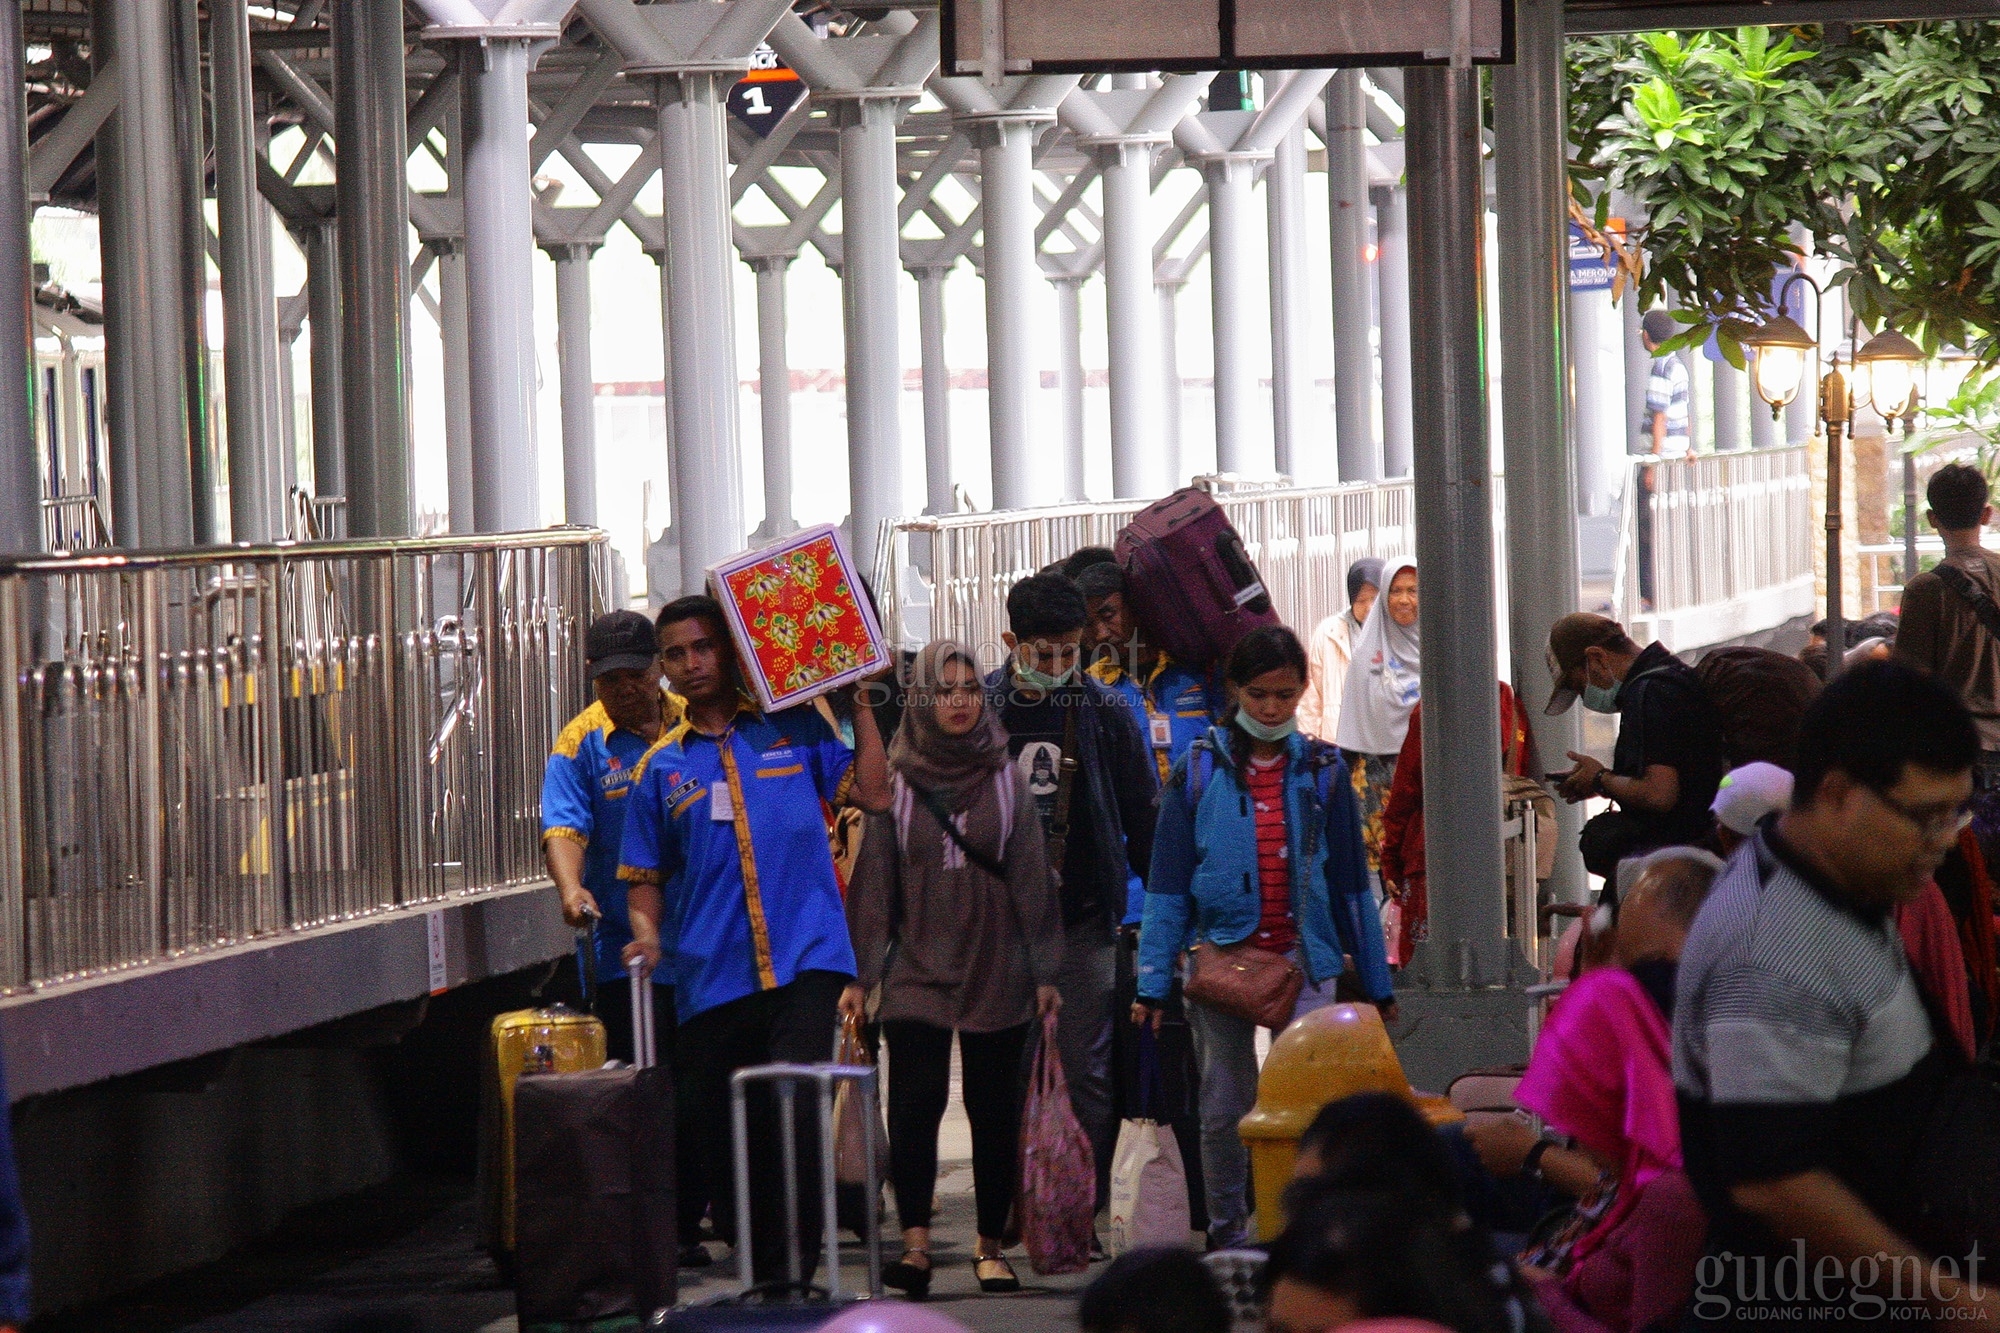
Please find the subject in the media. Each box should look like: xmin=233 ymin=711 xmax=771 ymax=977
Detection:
xmin=986 ymin=574 xmax=1158 ymax=1203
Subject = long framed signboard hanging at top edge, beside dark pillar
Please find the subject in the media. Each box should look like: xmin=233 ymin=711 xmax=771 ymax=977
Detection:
xmin=942 ymin=0 xmax=1514 ymax=74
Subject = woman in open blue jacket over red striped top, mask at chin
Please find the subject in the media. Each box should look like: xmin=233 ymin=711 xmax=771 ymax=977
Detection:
xmin=1132 ymin=626 xmax=1396 ymax=1247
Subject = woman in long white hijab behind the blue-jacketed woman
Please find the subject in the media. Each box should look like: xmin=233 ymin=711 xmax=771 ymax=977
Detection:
xmin=1334 ymin=556 xmax=1424 ymax=873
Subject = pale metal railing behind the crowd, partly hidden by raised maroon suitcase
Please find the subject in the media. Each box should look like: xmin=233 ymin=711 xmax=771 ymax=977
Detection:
xmin=874 ymin=480 xmax=1416 ymax=656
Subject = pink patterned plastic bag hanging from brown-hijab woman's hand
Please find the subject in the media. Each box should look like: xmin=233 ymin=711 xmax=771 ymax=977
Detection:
xmin=1018 ymin=1015 xmax=1098 ymax=1277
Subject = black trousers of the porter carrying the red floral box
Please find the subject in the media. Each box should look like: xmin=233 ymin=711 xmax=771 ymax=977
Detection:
xmin=674 ymin=971 xmax=848 ymax=1283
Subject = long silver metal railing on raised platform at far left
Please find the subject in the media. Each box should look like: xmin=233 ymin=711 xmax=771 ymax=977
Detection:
xmin=0 ymin=528 xmax=608 ymax=989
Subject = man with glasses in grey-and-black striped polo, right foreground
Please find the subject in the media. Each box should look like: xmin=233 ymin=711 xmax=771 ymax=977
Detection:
xmin=1674 ymin=662 xmax=2000 ymax=1327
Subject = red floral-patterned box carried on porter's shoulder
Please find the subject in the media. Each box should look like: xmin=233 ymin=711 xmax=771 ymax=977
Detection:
xmin=708 ymin=524 xmax=890 ymax=711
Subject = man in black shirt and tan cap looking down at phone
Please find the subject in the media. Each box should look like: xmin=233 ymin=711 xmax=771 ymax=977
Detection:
xmin=1548 ymin=612 xmax=1722 ymax=880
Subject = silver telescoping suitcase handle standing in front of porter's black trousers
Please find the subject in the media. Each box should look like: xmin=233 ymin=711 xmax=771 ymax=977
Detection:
xmin=730 ymin=1065 xmax=882 ymax=1301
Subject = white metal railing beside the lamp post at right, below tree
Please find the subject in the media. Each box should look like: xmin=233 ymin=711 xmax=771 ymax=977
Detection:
xmin=1612 ymin=444 xmax=1816 ymax=642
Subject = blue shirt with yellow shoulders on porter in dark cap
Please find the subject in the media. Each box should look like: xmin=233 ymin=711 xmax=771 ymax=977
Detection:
xmin=542 ymin=695 xmax=680 ymax=983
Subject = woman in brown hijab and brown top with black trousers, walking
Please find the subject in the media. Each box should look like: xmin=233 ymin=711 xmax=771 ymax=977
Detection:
xmin=840 ymin=642 xmax=1062 ymax=1299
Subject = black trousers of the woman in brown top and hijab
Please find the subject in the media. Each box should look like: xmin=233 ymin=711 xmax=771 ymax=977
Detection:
xmin=882 ymin=1019 xmax=1028 ymax=1239
